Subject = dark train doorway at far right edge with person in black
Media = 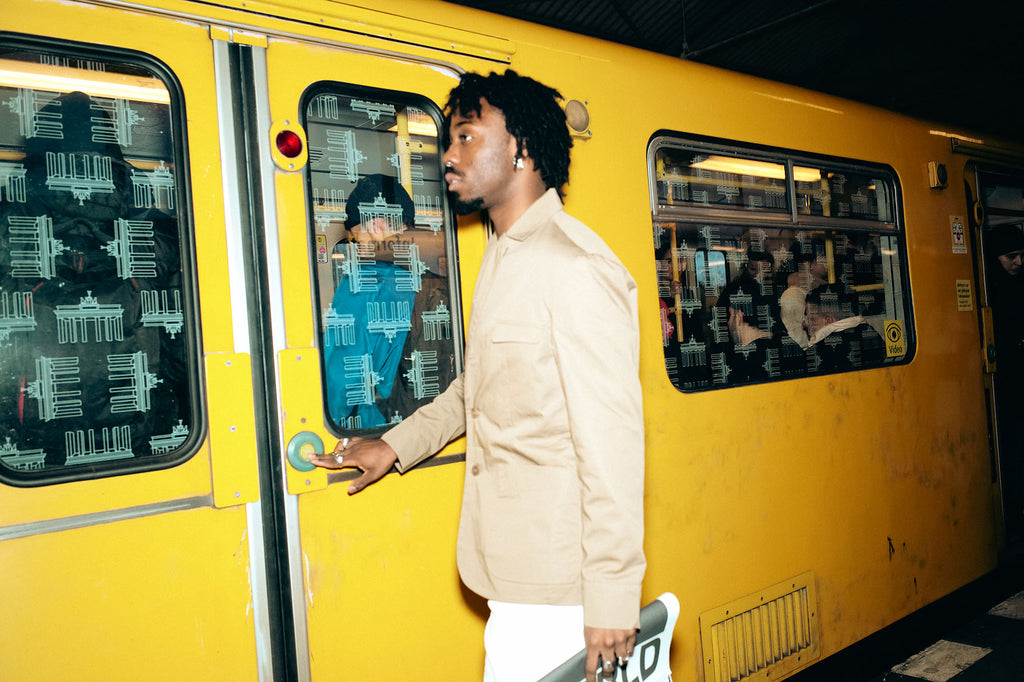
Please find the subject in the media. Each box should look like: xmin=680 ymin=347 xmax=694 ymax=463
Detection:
xmin=970 ymin=161 xmax=1024 ymax=542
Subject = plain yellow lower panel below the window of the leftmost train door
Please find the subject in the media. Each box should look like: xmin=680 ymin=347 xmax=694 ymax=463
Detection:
xmin=0 ymin=507 xmax=257 ymax=682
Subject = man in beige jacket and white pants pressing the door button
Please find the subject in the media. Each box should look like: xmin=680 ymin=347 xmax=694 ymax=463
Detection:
xmin=313 ymin=71 xmax=646 ymax=682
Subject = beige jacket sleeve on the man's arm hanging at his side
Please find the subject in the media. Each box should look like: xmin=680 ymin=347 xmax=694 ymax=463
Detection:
xmin=551 ymin=253 xmax=646 ymax=629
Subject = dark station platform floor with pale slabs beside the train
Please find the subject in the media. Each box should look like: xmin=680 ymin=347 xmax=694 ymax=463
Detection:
xmin=790 ymin=542 xmax=1024 ymax=682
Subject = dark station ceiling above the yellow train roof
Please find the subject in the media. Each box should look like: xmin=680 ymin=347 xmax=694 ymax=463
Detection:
xmin=451 ymin=0 xmax=1024 ymax=141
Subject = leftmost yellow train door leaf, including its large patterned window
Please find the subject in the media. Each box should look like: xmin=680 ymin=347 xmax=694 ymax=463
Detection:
xmin=0 ymin=0 xmax=267 ymax=680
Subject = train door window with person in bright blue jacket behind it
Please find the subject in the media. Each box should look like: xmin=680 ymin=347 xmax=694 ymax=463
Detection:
xmin=303 ymin=83 xmax=462 ymax=433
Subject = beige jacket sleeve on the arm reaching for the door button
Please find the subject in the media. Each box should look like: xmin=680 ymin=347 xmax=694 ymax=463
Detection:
xmin=382 ymin=368 xmax=466 ymax=473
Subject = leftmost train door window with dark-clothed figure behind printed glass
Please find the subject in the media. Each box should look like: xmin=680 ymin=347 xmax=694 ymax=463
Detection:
xmin=0 ymin=37 xmax=201 ymax=485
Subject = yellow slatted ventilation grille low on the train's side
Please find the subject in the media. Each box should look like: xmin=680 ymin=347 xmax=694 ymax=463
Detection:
xmin=700 ymin=571 xmax=819 ymax=682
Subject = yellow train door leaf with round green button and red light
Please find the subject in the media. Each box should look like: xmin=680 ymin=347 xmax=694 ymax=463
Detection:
xmin=254 ymin=29 xmax=484 ymax=680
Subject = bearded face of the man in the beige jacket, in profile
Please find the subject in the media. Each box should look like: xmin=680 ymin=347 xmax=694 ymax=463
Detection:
xmin=444 ymin=99 xmax=516 ymax=215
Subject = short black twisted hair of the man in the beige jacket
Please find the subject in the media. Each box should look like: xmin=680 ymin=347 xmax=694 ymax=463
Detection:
xmin=444 ymin=69 xmax=572 ymax=194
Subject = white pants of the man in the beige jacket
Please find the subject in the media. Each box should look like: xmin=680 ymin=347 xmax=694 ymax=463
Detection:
xmin=483 ymin=600 xmax=586 ymax=682
